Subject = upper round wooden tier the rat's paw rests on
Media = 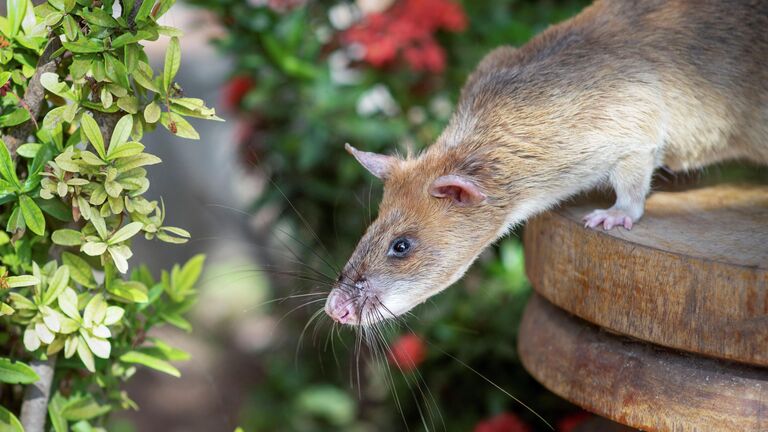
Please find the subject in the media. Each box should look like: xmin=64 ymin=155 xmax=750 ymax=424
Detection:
xmin=524 ymin=185 xmax=768 ymax=366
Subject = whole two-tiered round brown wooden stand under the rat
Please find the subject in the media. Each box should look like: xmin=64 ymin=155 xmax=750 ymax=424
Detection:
xmin=518 ymin=186 xmax=768 ymax=432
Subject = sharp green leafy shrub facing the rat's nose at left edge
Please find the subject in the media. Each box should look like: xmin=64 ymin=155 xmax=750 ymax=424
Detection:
xmin=0 ymin=0 xmax=218 ymax=432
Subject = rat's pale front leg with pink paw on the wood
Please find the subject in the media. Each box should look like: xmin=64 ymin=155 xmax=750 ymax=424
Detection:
xmin=583 ymin=153 xmax=654 ymax=230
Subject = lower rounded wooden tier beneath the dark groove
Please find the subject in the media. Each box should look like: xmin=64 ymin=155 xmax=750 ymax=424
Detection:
xmin=518 ymin=295 xmax=768 ymax=432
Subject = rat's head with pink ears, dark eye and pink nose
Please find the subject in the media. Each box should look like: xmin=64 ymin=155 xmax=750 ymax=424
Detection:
xmin=325 ymin=144 xmax=499 ymax=325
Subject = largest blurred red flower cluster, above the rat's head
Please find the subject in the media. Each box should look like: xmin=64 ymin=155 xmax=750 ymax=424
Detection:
xmin=342 ymin=0 xmax=467 ymax=73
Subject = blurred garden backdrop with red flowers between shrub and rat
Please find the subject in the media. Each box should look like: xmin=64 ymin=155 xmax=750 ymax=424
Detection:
xmin=96 ymin=0 xmax=752 ymax=432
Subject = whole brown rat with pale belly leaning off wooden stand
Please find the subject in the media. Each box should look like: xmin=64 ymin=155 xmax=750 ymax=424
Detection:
xmin=325 ymin=0 xmax=768 ymax=325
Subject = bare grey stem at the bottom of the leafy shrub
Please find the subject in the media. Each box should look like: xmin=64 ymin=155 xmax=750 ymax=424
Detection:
xmin=20 ymin=355 xmax=56 ymax=432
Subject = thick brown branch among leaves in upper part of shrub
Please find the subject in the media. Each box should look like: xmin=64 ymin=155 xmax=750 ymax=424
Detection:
xmin=3 ymin=35 xmax=61 ymax=157
